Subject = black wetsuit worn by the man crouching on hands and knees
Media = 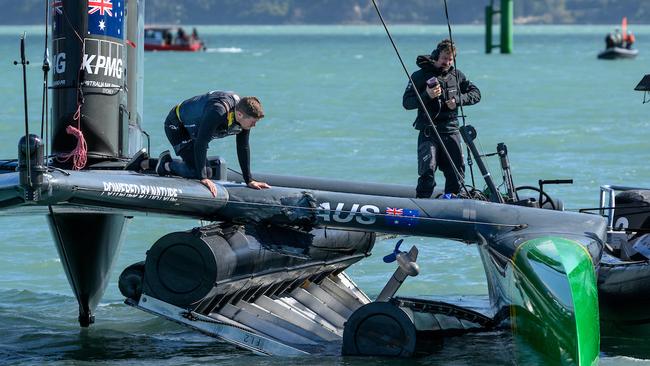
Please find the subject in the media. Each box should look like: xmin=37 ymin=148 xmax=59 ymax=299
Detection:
xmin=165 ymin=91 xmax=252 ymax=183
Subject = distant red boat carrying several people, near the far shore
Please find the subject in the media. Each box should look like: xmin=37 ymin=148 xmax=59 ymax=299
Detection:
xmin=144 ymin=26 xmax=205 ymax=52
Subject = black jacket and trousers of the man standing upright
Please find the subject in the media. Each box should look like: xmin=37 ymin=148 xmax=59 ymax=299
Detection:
xmin=402 ymin=55 xmax=481 ymax=198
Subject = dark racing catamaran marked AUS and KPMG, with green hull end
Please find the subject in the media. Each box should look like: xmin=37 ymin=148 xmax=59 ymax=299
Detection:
xmin=10 ymin=0 xmax=650 ymax=365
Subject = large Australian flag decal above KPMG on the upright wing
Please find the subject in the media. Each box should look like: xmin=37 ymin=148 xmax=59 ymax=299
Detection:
xmin=88 ymin=0 xmax=125 ymax=39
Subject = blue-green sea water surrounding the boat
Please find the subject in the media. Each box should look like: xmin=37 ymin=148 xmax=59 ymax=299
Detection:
xmin=0 ymin=25 xmax=650 ymax=366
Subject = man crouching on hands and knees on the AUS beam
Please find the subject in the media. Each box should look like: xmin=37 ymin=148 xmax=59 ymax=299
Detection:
xmin=156 ymin=91 xmax=270 ymax=196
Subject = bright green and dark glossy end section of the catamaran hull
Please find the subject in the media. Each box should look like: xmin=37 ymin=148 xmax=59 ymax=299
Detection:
xmin=509 ymin=237 xmax=600 ymax=365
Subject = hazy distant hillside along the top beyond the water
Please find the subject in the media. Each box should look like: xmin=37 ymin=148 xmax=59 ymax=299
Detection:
xmin=5 ymin=0 xmax=650 ymax=25
